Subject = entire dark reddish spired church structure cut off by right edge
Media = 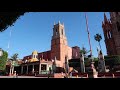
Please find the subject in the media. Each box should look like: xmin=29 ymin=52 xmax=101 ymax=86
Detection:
xmin=102 ymin=12 xmax=120 ymax=55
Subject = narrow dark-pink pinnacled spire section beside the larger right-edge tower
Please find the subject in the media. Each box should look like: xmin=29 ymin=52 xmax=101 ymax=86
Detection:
xmin=102 ymin=13 xmax=116 ymax=55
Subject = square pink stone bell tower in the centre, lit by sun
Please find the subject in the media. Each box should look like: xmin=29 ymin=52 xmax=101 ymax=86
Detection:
xmin=51 ymin=21 xmax=71 ymax=67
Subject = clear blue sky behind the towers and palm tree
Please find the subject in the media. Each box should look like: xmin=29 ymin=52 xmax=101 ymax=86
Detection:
xmin=0 ymin=12 xmax=110 ymax=59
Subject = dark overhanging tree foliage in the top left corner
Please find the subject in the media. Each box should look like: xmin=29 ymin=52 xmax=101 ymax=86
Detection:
xmin=0 ymin=12 xmax=25 ymax=32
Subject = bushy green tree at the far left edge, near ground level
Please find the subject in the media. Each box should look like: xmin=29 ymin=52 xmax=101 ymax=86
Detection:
xmin=0 ymin=50 xmax=8 ymax=71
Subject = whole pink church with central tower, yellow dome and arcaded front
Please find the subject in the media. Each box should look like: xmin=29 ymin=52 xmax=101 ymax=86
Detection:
xmin=16 ymin=22 xmax=80 ymax=74
